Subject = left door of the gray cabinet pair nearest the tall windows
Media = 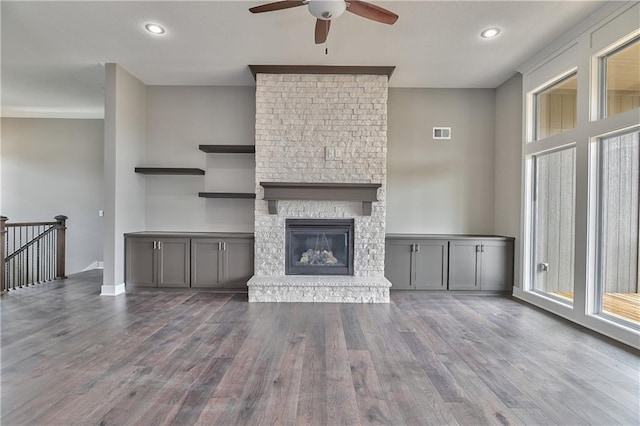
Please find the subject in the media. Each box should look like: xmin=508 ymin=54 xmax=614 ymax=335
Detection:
xmin=449 ymin=240 xmax=482 ymax=290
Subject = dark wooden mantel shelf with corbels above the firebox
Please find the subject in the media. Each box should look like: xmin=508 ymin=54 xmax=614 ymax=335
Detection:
xmin=260 ymin=182 xmax=382 ymax=216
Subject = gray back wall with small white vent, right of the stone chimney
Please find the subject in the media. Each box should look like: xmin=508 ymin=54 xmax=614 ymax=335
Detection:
xmin=387 ymin=89 xmax=495 ymax=234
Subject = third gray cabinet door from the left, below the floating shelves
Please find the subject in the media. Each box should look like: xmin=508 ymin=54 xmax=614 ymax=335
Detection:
xmin=191 ymin=238 xmax=222 ymax=287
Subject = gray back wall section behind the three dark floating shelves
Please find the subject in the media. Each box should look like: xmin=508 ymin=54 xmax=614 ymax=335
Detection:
xmin=145 ymin=86 xmax=255 ymax=232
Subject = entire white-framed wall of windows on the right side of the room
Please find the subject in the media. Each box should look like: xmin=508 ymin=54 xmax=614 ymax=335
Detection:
xmin=513 ymin=2 xmax=640 ymax=347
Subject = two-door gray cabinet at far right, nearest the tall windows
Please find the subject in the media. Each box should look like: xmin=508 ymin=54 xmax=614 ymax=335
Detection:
xmin=449 ymin=239 xmax=513 ymax=291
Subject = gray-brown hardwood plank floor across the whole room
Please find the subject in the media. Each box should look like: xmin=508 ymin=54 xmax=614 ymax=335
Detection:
xmin=0 ymin=271 xmax=640 ymax=425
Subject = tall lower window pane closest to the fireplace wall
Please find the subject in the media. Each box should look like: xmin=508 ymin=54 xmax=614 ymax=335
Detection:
xmin=533 ymin=148 xmax=576 ymax=301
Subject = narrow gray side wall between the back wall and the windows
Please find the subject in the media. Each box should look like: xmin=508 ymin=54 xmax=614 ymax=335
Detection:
xmin=493 ymin=74 xmax=522 ymax=286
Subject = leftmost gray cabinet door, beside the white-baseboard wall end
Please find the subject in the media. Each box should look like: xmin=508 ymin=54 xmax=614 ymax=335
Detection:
xmin=125 ymin=237 xmax=158 ymax=287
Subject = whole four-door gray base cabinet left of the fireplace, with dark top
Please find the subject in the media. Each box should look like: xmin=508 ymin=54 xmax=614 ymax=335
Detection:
xmin=125 ymin=232 xmax=253 ymax=289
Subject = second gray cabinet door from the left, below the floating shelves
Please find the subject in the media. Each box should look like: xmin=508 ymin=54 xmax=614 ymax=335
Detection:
xmin=157 ymin=238 xmax=191 ymax=287
